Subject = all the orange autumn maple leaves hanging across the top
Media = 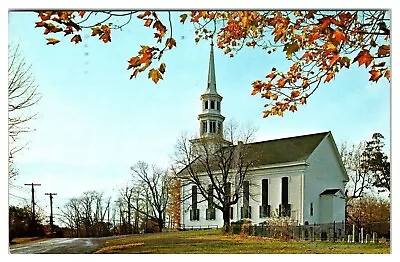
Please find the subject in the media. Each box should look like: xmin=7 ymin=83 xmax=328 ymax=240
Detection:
xmin=36 ymin=10 xmax=390 ymax=117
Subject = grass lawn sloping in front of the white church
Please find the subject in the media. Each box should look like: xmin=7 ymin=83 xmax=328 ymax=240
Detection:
xmin=96 ymin=230 xmax=390 ymax=254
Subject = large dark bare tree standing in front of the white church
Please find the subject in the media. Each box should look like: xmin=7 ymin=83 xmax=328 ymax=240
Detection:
xmin=174 ymin=121 xmax=256 ymax=232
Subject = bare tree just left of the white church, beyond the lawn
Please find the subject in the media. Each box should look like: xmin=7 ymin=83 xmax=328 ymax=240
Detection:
xmin=131 ymin=161 xmax=171 ymax=231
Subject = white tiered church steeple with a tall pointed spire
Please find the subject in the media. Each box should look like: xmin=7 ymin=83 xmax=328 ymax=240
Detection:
xmin=197 ymin=42 xmax=225 ymax=137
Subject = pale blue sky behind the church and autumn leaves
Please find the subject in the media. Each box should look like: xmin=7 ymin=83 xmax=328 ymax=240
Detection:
xmin=8 ymin=9 xmax=391 ymax=223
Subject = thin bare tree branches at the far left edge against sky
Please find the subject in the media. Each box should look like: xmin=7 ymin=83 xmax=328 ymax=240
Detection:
xmin=8 ymin=44 xmax=41 ymax=178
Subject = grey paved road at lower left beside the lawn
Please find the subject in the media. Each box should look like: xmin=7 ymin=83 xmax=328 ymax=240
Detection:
xmin=9 ymin=236 xmax=121 ymax=254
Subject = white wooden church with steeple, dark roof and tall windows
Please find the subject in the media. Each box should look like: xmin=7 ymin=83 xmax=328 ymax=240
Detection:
xmin=181 ymin=44 xmax=349 ymax=228
